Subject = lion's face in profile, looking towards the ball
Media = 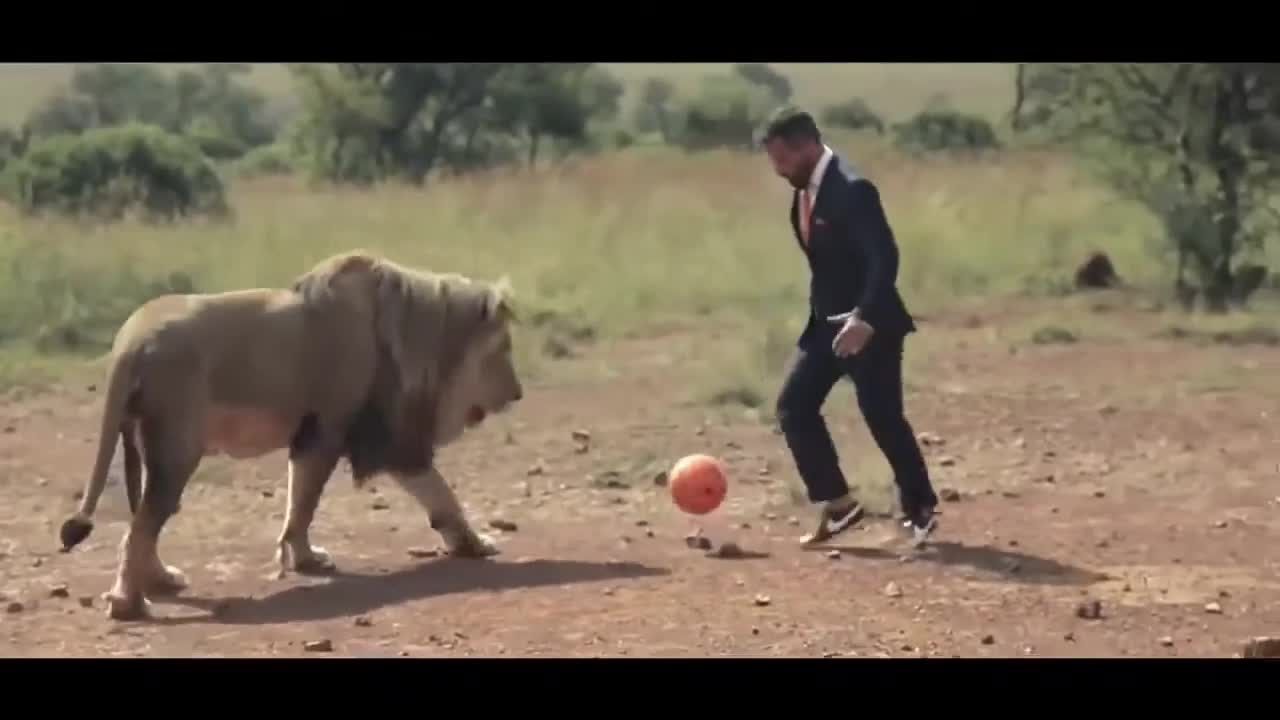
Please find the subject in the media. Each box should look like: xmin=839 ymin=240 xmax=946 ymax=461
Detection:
xmin=436 ymin=311 xmax=525 ymax=442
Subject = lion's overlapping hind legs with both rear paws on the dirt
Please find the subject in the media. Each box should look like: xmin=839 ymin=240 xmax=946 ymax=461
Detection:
xmin=106 ymin=406 xmax=204 ymax=620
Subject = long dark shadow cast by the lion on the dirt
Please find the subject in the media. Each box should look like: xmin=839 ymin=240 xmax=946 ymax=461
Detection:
xmin=161 ymin=557 xmax=669 ymax=625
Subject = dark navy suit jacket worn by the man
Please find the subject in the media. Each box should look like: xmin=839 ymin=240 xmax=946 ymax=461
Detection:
xmin=791 ymin=154 xmax=916 ymax=348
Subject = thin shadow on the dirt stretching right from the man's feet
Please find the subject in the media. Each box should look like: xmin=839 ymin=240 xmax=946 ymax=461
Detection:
xmin=814 ymin=542 xmax=1111 ymax=585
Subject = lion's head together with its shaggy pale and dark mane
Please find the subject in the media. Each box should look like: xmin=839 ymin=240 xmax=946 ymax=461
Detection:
xmin=294 ymin=245 xmax=524 ymax=468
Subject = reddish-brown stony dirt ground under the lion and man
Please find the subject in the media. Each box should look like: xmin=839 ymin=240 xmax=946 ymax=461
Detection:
xmin=0 ymin=294 xmax=1280 ymax=657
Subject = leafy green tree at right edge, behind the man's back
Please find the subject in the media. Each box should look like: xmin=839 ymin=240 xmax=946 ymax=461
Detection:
xmin=1020 ymin=63 xmax=1280 ymax=311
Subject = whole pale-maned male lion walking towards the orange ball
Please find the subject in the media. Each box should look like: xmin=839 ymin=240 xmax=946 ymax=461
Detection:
xmin=60 ymin=251 xmax=524 ymax=620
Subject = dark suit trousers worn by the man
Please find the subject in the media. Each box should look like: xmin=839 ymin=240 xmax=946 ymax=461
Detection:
xmin=777 ymin=334 xmax=937 ymax=512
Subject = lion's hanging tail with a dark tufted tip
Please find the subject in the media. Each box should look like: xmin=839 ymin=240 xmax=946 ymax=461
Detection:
xmin=60 ymin=350 xmax=141 ymax=552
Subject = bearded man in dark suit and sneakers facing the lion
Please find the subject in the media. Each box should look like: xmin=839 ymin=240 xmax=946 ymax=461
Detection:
xmin=763 ymin=109 xmax=937 ymax=543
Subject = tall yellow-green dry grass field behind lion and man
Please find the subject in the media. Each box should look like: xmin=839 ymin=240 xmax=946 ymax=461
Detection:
xmin=0 ymin=130 xmax=1269 ymax=397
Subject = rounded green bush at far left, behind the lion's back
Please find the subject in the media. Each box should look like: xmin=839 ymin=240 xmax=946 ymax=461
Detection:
xmin=0 ymin=123 xmax=229 ymax=219
